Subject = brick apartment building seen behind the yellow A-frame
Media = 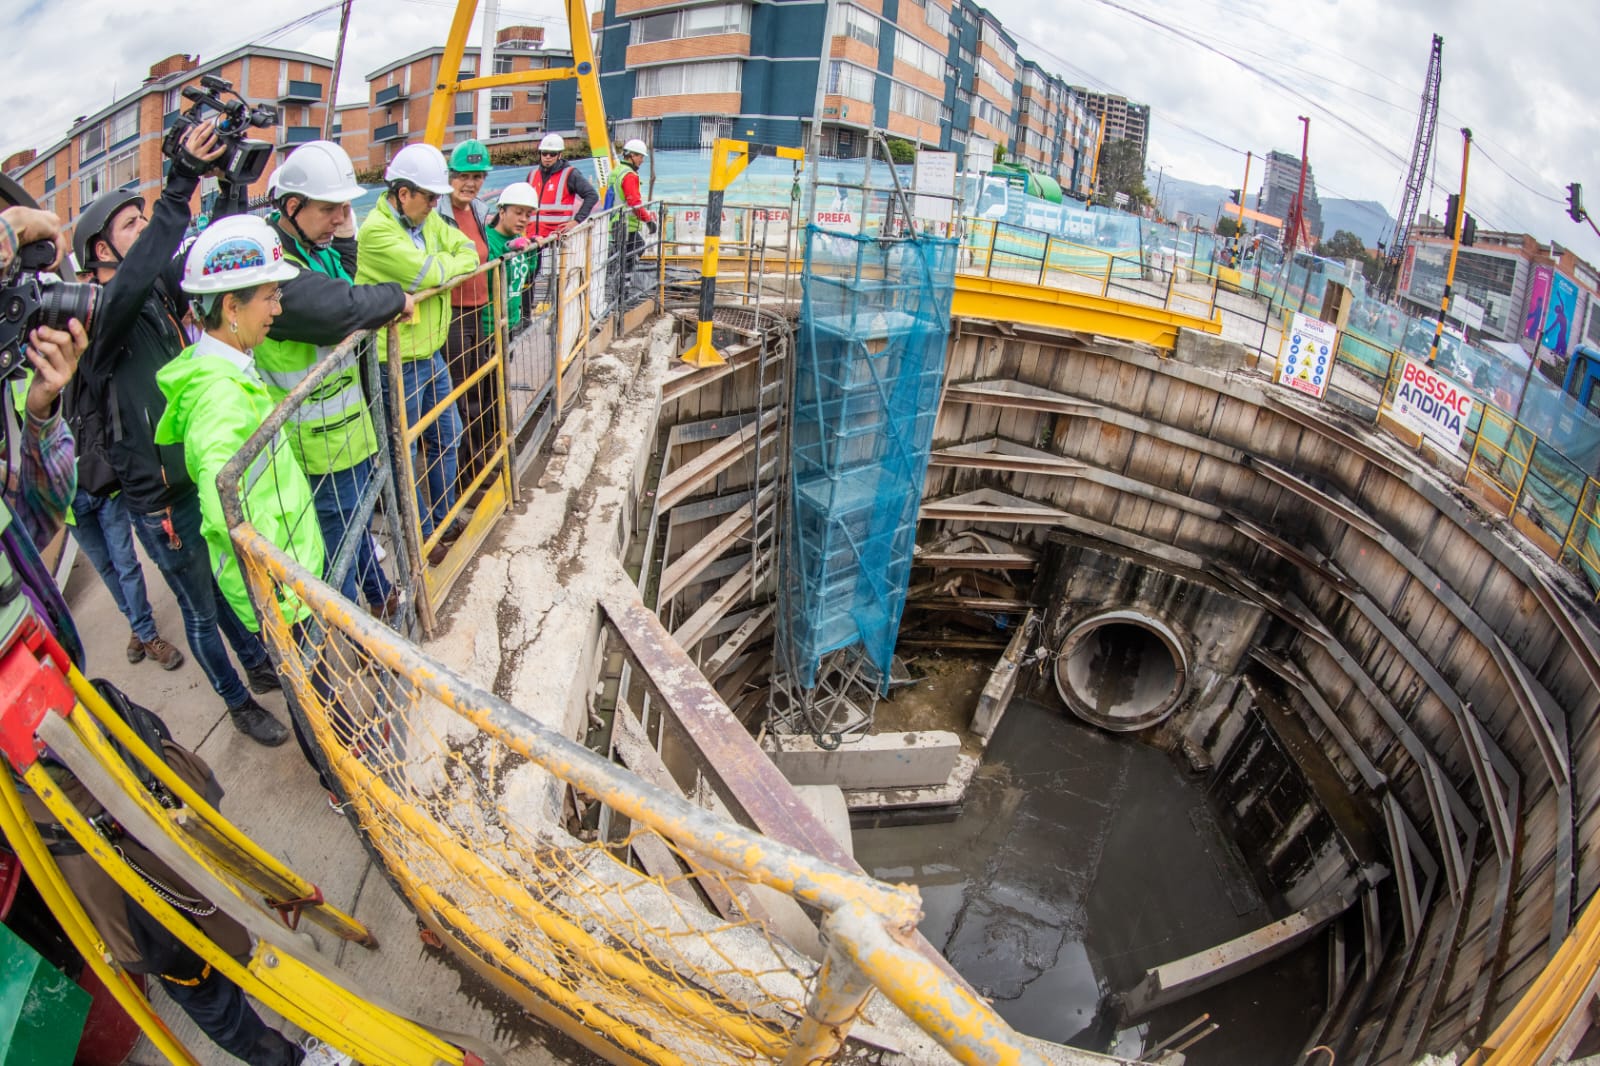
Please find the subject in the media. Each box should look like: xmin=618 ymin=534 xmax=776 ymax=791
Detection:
xmin=363 ymin=26 xmax=582 ymax=170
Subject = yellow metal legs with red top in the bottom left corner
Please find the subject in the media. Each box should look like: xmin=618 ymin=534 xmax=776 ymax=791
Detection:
xmin=0 ymin=621 xmax=488 ymax=1066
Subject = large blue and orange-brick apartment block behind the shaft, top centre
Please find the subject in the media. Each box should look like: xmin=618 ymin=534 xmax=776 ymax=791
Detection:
xmin=597 ymin=0 xmax=1107 ymax=190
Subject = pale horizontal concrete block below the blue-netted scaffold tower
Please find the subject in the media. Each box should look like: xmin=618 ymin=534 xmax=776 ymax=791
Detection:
xmin=762 ymin=730 xmax=962 ymax=791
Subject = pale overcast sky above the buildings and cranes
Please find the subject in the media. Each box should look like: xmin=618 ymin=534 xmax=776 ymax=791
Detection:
xmin=12 ymin=0 xmax=1600 ymax=266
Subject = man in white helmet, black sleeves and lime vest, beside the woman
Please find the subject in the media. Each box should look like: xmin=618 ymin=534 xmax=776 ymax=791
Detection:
xmin=254 ymin=141 xmax=411 ymax=619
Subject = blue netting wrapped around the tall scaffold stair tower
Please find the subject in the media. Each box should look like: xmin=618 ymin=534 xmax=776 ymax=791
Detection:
xmin=779 ymin=226 xmax=957 ymax=693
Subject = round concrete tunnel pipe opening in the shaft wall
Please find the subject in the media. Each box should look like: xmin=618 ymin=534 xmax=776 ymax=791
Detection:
xmin=1056 ymin=610 xmax=1189 ymax=733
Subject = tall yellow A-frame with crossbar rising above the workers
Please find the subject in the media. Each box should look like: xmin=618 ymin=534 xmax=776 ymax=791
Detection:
xmin=422 ymin=0 xmax=611 ymax=182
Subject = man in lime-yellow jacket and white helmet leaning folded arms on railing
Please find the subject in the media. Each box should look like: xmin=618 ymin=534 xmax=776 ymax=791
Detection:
xmin=355 ymin=144 xmax=478 ymax=565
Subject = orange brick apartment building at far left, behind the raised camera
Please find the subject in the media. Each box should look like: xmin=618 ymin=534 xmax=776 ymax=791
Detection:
xmin=0 ymin=45 xmax=333 ymax=228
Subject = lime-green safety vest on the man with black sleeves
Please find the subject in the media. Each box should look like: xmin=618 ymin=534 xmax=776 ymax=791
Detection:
xmin=254 ymin=232 xmax=378 ymax=477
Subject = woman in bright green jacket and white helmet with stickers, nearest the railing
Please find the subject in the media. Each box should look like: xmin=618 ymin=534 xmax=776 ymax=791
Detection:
xmin=155 ymin=214 xmax=354 ymax=792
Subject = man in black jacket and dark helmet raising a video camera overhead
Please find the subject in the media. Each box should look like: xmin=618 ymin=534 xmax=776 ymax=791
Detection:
xmin=72 ymin=120 xmax=290 ymax=747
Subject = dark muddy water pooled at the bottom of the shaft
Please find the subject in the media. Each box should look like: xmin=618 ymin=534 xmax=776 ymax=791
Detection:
xmin=854 ymin=701 xmax=1326 ymax=1066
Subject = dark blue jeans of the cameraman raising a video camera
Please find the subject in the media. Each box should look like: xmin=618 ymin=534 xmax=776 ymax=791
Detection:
xmin=133 ymin=493 xmax=269 ymax=707
